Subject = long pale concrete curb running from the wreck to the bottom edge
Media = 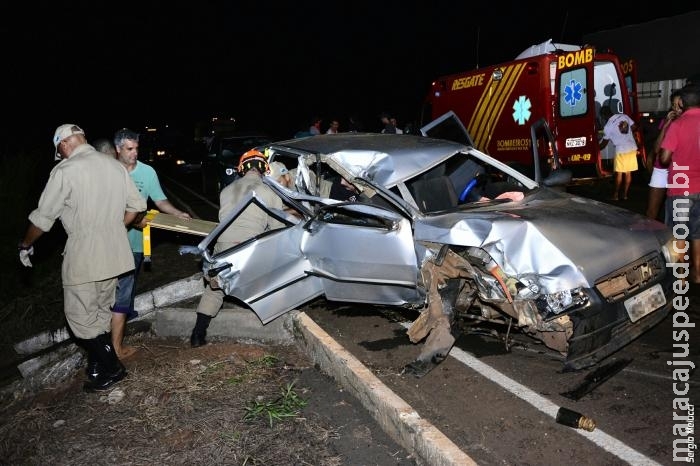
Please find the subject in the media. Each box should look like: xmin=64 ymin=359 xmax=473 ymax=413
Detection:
xmin=294 ymin=312 xmax=477 ymax=466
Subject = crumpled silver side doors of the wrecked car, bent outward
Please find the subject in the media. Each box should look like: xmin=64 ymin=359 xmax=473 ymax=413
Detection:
xmin=199 ymin=189 xmax=422 ymax=324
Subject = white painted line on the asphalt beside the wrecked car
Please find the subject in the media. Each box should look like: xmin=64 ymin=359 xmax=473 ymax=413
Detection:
xmin=401 ymin=322 xmax=661 ymax=466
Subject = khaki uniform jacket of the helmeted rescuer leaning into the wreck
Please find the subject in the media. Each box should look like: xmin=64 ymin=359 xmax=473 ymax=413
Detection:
xmin=217 ymin=170 xmax=284 ymax=243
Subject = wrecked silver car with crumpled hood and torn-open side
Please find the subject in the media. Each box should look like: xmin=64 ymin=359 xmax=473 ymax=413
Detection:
xmin=187 ymin=116 xmax=674 ymax=377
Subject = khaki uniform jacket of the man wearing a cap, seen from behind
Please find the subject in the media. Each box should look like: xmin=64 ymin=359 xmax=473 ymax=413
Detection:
xmin=29 ymin=144 xmax=146 ymax=286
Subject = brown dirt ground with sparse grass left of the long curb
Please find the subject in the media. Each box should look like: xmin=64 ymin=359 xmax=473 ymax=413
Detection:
xmin=0 ymin=236 xmax=416 ymax=466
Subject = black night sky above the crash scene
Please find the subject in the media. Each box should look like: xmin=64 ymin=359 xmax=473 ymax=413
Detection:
xmin=0 ymin=0 xmax=697 ymax=152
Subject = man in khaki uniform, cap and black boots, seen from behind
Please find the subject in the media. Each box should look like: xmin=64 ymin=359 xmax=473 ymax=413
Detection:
xmin=18 ymin=124 xmax=146 ymax=391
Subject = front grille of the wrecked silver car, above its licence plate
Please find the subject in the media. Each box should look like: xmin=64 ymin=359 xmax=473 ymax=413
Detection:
xmin=595 ymin=252 xmax=666 ymax=303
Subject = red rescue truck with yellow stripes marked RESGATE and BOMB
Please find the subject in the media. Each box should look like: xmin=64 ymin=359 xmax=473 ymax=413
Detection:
xmin=422 ymin=40 xmax=646 ymax=180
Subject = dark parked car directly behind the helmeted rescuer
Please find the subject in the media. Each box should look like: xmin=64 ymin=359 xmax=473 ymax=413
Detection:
xmin=202 ymin=132 xmax=272 ymax=192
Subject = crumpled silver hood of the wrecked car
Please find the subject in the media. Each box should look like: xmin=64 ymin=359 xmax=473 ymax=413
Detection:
xmin=415 ymin=188 xmax=670 ymax=292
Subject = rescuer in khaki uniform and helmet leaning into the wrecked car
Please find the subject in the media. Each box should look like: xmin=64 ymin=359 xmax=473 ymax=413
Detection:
xmin=190 ymin=150 xmax=288 ymax=347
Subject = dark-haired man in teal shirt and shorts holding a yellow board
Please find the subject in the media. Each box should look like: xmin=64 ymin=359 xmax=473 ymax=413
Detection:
xmin=112 ymin=128 xmax=192 ymax=358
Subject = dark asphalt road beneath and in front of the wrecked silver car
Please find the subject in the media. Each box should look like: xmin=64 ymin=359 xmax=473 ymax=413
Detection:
xmin=164 ymin=166 xmax=700 ymax=465
